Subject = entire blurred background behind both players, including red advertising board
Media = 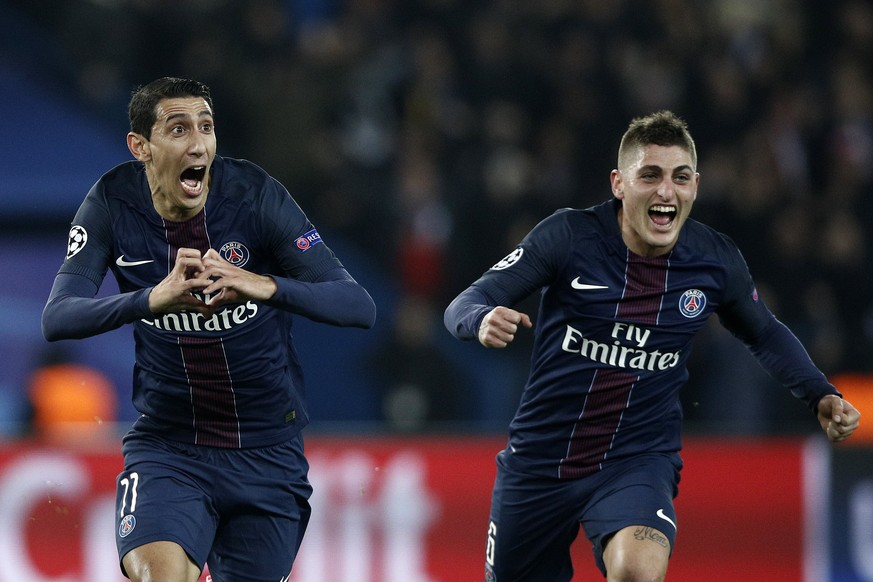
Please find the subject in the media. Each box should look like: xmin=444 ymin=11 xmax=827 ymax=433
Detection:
xmin=0 ymin=0 xmax=873 ymax=582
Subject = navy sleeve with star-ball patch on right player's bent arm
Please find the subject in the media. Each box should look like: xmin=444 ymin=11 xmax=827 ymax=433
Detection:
xmin=443 ymin=211 xmax=573 ymax=340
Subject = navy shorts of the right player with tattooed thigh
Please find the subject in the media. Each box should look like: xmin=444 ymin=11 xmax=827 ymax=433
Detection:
xmin=485 ymin=451 xmax=682 ymax=582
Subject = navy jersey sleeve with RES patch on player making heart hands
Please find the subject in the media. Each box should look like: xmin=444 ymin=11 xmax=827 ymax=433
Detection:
xmin=254 ymin=179 xmax=376 ymax=328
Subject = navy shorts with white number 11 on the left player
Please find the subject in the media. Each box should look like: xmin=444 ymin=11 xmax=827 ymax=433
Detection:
xmin=115 ymin=433 xmax=312 ymax=582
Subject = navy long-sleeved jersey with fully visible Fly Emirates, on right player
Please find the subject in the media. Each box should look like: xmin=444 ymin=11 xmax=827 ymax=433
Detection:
xmin=445 ymin=200 xmax=837 ymax=478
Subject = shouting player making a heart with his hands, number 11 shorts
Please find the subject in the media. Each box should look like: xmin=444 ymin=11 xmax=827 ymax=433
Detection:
xmin=42 ymin=78 xmax=376 ymax=582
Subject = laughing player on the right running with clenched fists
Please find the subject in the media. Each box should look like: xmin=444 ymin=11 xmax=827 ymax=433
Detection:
xmin=445 ymin=111 xmax=860 ymax=582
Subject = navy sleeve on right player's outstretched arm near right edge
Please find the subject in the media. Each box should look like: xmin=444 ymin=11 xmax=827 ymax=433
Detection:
xmin=718 ymin=237 xmax=840 ymax=411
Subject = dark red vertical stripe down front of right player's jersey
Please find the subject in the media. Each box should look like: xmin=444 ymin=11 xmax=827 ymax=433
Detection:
xmin=558 ymin=252 xmax=669 ymax=479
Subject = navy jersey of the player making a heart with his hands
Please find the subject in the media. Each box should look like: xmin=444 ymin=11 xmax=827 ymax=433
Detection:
xmin=43 ymin=156 xmax=375 ymax=448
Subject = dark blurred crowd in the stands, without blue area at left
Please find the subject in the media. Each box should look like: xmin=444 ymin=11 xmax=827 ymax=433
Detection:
xmin=9 ymin=0 xmax=873 ymax=436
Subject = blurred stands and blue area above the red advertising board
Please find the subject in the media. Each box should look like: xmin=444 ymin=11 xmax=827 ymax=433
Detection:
xmin=0 ymin=0 xmax=873 ymax=434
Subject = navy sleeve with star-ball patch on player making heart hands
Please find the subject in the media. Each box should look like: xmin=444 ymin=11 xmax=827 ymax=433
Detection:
xmin=42 ymin=182 xmax=150 ymax=341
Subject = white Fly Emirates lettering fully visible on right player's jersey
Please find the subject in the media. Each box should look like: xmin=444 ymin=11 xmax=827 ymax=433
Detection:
xmin=561 ymin=322 xmax=679 ymax=372
